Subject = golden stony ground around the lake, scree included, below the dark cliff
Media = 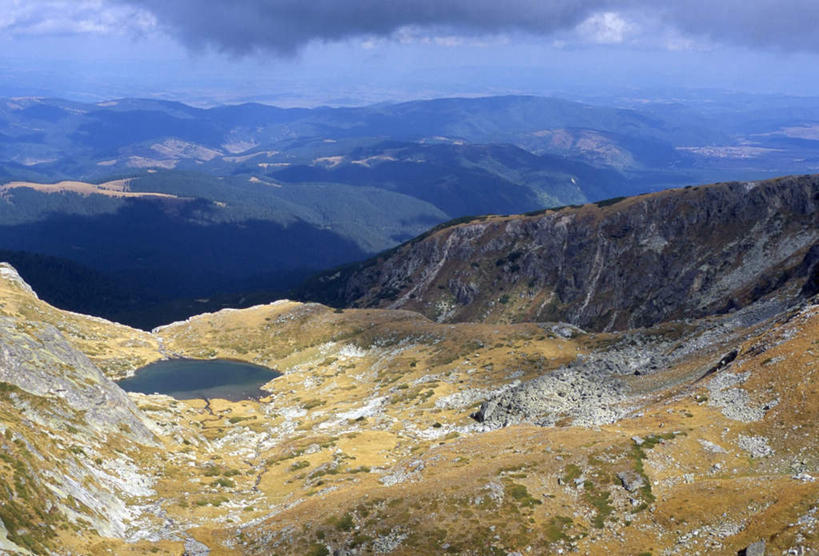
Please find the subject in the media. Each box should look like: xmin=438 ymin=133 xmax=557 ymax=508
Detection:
xmin=0 ymin=267 xmax=819 ymax=555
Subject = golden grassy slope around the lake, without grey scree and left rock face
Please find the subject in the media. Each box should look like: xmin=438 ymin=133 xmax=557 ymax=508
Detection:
xmin=0 ymin=266 xmax=819 ymax=554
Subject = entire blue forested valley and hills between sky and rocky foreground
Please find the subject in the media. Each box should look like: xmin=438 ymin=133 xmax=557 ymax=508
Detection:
xmin=0 ymin=93 xmax=819 ymax=330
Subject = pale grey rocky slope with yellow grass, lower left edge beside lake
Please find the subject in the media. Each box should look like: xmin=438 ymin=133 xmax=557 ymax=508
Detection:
xmin=0 ymin=264 xmax=157 ymax=553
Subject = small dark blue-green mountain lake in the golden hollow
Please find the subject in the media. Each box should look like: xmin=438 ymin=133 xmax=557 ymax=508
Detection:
xmin=117 ymin=359 xmax=281 ymax=402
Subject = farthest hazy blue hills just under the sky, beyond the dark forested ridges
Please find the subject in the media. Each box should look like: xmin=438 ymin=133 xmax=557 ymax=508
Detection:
xmin=0 ymin=92 xmax=819 ymax=186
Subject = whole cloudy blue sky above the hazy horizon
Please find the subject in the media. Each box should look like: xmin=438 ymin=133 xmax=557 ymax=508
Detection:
xmin=0 ymin=0 xmax=819 ymax=106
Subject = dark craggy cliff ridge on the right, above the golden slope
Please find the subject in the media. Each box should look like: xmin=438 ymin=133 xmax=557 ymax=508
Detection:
xmin=303 ymin=175 xmax=819 ymax=330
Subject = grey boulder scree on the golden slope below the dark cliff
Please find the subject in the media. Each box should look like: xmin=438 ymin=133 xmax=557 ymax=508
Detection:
xmin=472 ymin=302 xmax=782 ymax=430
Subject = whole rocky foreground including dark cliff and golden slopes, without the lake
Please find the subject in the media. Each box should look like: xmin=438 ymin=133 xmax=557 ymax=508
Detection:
xmin=0 ymin=176 xmax=819 ymax=555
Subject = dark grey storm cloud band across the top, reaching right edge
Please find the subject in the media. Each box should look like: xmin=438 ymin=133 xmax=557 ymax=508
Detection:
xmin=119 ymin=0 xmax=819 ymax=53
